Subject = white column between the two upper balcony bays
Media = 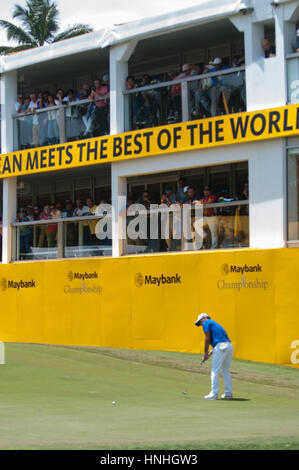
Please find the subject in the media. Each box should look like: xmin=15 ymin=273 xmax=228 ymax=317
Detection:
xmin=109 ymin=41 xmax=137 ymax=134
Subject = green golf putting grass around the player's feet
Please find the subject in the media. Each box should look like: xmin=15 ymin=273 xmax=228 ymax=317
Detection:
xmin=0 ymin=344 xmax=299 ymax=449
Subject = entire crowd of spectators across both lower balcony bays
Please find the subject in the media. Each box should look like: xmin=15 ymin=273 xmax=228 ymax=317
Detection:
xmin=16 ymin=179 xmax=249 ymax=259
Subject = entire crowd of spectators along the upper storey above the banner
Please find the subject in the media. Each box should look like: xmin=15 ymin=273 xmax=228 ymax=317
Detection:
xmin=7 ymin=25 xmax=299 ymax=149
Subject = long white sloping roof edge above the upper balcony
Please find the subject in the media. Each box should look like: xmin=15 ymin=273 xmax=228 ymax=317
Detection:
xmin=0 ymin=0 xmax=248 ymax=73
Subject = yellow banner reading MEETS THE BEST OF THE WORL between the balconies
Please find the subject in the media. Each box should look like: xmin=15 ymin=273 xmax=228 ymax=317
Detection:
xmin=0 ymin=105 xmax=299 ymax=178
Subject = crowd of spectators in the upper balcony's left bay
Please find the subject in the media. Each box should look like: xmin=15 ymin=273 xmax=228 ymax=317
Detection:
xmin=15 ymin=74 xmax=109 ymax=149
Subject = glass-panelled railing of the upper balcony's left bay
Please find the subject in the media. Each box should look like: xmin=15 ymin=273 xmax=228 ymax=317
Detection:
xmin=13 ymin=98 xmax=109 ymax=150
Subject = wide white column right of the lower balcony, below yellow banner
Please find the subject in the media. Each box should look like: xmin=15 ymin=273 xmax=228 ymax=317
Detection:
xmin=248 ymin=139 xmax=287 ymax=249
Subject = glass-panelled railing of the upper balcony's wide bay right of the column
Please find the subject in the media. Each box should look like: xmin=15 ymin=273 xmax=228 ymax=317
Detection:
xmin=123 ymin=67 xmax=246 ymax=131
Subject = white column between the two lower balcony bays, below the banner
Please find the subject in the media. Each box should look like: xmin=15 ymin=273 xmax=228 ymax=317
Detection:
xmin=111 ymin=163 xmax=127 ymax=258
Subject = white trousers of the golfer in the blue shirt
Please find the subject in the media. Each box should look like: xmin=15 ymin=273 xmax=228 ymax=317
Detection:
xmin=211 ymin=341 xmax=233 ymax=395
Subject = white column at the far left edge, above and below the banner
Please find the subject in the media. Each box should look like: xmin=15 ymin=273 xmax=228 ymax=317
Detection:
xmin=1 ymin=72 xmax=17 ymax=263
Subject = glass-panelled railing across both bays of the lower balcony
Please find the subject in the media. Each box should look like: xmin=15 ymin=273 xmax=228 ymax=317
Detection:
xmin=12 ymin=201 xmax=249 ymax=261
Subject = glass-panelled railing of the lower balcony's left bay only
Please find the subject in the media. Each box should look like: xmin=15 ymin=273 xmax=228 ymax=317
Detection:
xmin=12 ymin=216 xmax=112 ymax=261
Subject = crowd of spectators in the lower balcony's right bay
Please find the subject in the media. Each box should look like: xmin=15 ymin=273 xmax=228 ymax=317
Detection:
xmin=127 ymin=179 xmax=249 ymax=252
